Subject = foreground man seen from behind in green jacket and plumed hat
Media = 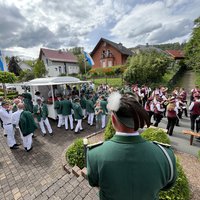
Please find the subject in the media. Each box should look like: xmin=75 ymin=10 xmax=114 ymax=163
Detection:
xmin=87 ymin=92 xmax=176 ymax=200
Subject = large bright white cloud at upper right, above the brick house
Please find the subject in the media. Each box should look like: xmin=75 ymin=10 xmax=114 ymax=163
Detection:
xmin=111 ymin=0 xmax=200 ymax=46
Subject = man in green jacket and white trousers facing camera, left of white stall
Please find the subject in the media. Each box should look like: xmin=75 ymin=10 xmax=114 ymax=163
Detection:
xmin=33 ymin=98 xmax=53 ymax=136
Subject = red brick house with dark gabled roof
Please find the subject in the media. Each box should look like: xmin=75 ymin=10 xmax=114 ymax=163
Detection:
xmin=90 ymin=38 xmax=133 ymax=68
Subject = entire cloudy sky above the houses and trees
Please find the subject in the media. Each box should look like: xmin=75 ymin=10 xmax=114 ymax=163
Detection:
xmin=0 ymin=0 xmax=200 ymax=58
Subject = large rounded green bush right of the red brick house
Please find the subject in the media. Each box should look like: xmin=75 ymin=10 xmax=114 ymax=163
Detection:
xmin=124 ymin=51 xmax=170 ymax=84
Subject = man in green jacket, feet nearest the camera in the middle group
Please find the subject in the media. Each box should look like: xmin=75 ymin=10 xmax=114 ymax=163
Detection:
xmin=73 ymin=97 xmax=83 ymax=133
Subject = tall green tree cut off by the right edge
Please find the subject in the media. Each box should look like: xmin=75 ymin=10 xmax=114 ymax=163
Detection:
xmin=185 ymin=17 xmax=200 ymax=71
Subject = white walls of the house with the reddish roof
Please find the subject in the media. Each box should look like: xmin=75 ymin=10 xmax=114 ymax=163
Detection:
xmin=42 ymin=55 xmax=80 ymax=77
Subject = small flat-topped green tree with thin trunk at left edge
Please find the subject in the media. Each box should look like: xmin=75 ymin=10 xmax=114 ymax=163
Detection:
xmin=0 ymin=71 xmax=17 ymax=98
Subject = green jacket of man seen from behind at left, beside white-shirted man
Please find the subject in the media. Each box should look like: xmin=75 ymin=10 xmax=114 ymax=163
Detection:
xmin=19 ymin=111 xmax=37 ymax=136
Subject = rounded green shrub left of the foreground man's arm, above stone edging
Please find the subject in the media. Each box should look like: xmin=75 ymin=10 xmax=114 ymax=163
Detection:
xmin=66 ymin=138 xmax=85 ymax=169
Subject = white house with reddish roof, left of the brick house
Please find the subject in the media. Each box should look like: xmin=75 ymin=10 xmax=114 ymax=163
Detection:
xmin=39 ymin=48 xmax=80 ymax=77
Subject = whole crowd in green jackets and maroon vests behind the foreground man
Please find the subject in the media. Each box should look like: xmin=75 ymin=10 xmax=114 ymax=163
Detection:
xmin=0 ymin=83 xmax=200 ymax=151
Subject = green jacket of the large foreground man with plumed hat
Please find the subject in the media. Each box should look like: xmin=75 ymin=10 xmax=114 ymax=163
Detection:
xmin=87 ymin=135 xmax=176 ymax=200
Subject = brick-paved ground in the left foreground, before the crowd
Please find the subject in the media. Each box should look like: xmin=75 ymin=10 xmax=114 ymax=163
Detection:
xmin=0 ymin=121 xmax=99 ymax=200
